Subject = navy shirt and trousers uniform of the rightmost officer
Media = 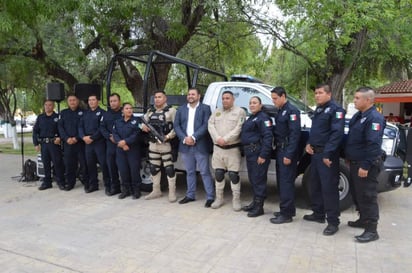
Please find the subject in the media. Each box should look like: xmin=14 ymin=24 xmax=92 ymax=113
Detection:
xmin=345 ymin=106 xmax=385 ymax=223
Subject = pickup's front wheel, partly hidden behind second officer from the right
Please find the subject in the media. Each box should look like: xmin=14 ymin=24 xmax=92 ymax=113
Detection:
xmin=302 ymin=160 xmax=353 ymax=211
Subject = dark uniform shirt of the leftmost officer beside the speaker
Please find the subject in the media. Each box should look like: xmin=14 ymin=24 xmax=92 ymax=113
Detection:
xmin=33 ymin=112 xmax=59 ymax=146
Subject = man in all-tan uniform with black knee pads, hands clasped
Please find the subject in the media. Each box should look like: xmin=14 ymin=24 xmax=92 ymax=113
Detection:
xmin=208 ymin=90 xmax=246 ymax=211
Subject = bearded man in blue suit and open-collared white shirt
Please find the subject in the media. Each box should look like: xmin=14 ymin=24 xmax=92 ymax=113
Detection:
xmin=174 ymin=88 xmax=215 ymax=208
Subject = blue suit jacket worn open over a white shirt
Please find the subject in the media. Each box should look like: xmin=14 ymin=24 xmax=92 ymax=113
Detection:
xmin=173 ymin=103 xmax=212 ymax=153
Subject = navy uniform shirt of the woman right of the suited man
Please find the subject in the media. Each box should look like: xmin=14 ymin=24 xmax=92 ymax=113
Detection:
xmin=240 ymin=111 xmax=273 ymax=159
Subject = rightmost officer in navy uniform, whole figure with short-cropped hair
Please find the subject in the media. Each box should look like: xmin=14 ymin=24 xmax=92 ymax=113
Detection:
xmin=345 ymin=87 xmax=385 ymax=243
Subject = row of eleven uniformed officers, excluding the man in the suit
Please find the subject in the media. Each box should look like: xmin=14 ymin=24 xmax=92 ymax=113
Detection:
xmin=33 ymin=84 xmax=385 ymax=242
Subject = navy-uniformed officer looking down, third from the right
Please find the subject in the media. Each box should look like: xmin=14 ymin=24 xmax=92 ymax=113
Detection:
xmin=270 ymin=86 xmax=300 ymax=224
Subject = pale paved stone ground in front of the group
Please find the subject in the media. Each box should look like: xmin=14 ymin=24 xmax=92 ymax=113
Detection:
xmin=0 ymin=153 xmax=412 ymax=273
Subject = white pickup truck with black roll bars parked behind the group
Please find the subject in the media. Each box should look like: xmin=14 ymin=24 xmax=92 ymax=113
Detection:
xmin=107 ymin=52 xmax=403 ymax=210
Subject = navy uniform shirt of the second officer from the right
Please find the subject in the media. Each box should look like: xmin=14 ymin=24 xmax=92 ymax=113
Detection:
xmin=308 ymin=100 xmax=345 ymax=158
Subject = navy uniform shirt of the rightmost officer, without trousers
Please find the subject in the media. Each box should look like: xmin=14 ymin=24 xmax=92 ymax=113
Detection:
xmin=345 ymin=106 xmax=386 ymax=170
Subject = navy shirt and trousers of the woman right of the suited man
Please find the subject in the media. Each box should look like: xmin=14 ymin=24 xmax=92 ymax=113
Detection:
xmin=240 ymin=111 xmax=273 ymax=199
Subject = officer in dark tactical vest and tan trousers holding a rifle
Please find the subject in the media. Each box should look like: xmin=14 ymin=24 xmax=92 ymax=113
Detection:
xmin=142 ymin=90 xmax=176 ymax=202
